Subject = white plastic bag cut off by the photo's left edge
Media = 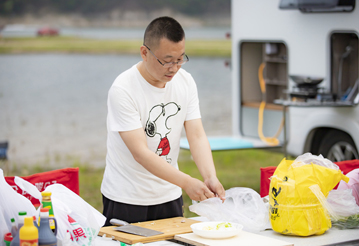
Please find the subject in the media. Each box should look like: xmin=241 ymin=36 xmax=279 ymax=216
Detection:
xmin=0 ymin=168 xmax=36 ymax=245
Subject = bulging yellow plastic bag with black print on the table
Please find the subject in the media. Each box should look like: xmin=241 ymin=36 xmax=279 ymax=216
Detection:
xmin=269 ymin=158 xmax=349 ymax=236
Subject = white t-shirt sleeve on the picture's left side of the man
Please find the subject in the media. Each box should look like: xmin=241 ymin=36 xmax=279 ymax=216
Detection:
xmin=107 ymin=86 xmax=142 ymax=132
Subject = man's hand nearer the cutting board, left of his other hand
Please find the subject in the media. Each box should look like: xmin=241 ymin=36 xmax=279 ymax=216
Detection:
xmin=182 ymin=177 xmax=215 ymax=201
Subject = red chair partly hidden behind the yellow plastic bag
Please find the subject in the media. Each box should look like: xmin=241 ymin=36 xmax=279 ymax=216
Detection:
xmin=260 ymin=160 xmax=359 ymax=197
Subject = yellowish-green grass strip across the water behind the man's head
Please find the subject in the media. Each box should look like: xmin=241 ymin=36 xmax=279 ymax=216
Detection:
xmin=0 ymin=36 xmax=231 ymax=57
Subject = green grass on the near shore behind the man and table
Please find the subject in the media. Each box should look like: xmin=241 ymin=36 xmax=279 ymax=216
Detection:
xmin=0 ymin=149 xmax=283 ymax=217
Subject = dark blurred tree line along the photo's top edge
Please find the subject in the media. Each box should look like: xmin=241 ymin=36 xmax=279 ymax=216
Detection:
xmin=0 ymin=0 xmax=231 ymax=16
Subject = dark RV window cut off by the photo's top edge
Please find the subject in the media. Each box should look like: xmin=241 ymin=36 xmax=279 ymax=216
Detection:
xmin=279 ymin=0 xmax=355 ymax=13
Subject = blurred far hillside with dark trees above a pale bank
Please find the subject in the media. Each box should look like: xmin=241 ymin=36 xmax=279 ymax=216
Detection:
xmin=0 ymin=0 xmax=230 ymax=27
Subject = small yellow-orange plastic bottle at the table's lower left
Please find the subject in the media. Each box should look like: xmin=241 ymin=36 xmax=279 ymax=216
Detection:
xmin=19 ymin=217 xmax=39 ymax=246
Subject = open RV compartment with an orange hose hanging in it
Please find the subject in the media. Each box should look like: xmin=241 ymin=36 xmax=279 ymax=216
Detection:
xmin=239 ymin=42 xmax=288 ymax=138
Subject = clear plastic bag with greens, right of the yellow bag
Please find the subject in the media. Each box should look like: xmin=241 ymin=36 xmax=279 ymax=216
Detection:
xmin=309 ymin=185 xmax=359 ymax=229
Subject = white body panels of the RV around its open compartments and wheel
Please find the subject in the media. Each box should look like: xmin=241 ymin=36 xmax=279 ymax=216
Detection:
xmin=231 ymin=0 xmax=359 ymax=160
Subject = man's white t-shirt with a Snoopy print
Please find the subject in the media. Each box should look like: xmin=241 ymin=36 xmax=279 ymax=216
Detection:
xmin=101 ymin=64 xmax=201 ymax=205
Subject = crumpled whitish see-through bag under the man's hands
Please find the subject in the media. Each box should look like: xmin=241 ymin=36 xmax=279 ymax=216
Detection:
xmin=189 ymin=187 xmax=271 ymax=232
